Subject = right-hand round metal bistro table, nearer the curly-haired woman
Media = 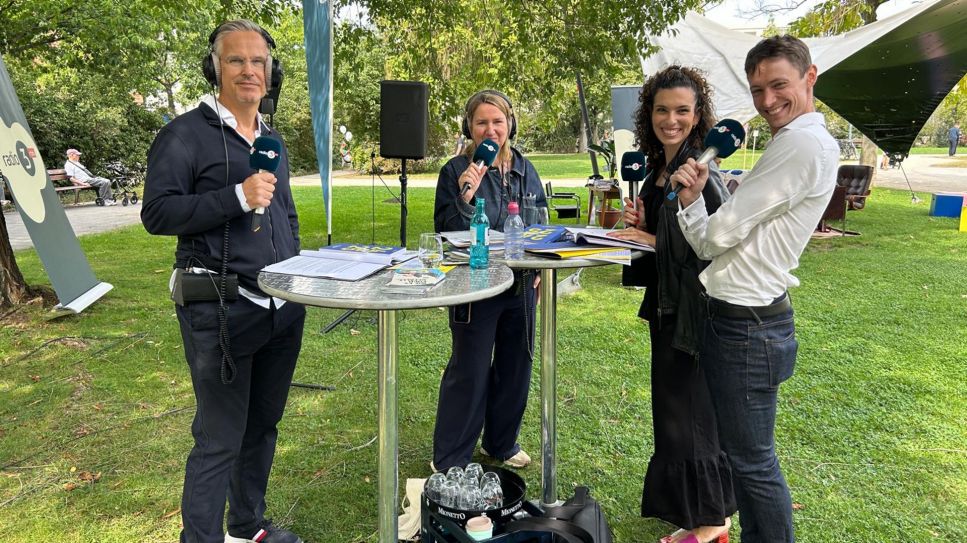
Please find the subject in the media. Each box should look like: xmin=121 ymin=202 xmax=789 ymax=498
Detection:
xmin=497 ymin=253 xmax=611 ymax=506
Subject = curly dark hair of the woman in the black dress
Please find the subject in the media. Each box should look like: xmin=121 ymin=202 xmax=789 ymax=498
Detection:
xmin=635 ymin=66 xmax=715 ymax=169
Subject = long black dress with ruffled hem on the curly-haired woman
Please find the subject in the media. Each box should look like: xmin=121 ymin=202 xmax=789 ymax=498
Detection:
xmin=639 ymin=152 xmax=736 ymax=529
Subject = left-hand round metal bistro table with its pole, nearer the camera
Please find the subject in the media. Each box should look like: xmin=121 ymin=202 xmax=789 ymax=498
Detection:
xmin=259 ymin=263 xmax=514 ymax=543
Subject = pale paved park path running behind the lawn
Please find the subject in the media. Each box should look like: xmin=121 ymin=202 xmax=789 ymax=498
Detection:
xmin=3 ymin=155 xmax=967 ymax=250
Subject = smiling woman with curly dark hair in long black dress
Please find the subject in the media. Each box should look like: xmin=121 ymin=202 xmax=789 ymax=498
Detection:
xmin=610 ymin=66 xmax=736 ymax=543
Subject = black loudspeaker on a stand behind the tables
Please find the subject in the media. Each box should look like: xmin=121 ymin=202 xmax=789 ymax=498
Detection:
xmin=379 ymin=80 xmax=430 ymax=247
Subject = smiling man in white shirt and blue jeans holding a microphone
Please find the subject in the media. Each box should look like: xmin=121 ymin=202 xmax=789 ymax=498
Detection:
xmin=671 ymin=36 xmax=839 ymax=543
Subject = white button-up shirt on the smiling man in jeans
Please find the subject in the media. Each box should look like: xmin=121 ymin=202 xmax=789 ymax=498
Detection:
xmin=678 ymin=112 xmax=839 ymax=307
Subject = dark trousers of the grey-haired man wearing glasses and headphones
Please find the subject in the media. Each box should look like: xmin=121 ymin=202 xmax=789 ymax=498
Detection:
xmin=175 ymin=297 xmax=305 ymax=543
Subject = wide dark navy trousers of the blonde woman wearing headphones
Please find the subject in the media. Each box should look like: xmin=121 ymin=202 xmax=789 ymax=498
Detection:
xmin=433 ymin=280 xmax=535 ymax=471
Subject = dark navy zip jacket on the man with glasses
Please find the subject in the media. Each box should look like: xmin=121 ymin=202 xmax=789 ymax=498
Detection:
xmin=141 ymin=104 xmax=299 ymax=293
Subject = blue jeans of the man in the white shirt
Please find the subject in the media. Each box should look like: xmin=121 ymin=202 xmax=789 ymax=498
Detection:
xmin=700 ymin=300 xmax=798 ymax=543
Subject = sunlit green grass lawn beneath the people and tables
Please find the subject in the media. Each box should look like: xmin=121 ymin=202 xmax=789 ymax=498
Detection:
xmin=0 ymin=187 xmax=967 ymax=543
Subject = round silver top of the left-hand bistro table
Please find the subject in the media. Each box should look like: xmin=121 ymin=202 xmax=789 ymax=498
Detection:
xmin=259 ymin=262 xmax=514 ymax=310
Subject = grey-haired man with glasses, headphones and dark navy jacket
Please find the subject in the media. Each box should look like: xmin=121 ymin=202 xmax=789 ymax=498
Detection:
xmin=141 ymin=20 xmax=305 ymax=543
